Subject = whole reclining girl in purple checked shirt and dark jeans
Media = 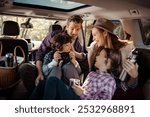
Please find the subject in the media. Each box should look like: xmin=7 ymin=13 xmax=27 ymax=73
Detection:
xmin=43 ymin=48 xmax=121 ymax=100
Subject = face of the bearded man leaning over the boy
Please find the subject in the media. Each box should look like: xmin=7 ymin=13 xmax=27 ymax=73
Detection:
xmin=66 ymin=22 xmax=81 ymax=40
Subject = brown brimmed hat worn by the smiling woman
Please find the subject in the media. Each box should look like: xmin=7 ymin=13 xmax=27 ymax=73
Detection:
xmin=93 ymin=18 xmax=116 ymax=36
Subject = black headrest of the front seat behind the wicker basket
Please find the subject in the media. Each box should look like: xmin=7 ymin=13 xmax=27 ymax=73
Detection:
xmin=2 ymin=21 xmax=20 ymax=36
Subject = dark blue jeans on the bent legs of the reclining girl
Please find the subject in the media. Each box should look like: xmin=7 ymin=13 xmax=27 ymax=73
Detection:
xmin=43 ymin=77 xmax=80 ymax=100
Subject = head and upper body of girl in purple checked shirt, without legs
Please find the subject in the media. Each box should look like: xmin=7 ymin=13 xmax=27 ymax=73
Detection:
xmin=73 ymin=48 xmax=121 ymax=99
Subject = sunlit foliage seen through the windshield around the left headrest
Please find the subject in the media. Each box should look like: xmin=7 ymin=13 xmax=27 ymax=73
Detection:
xmin=0 ymin=15 xmax=55 ymax=41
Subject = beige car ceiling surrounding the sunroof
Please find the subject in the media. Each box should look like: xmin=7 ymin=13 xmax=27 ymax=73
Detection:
xmin=0 ymin=0 xmax=150 ymax=19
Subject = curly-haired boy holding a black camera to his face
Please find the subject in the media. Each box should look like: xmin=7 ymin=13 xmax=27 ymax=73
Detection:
xmin=42 ymin=33 xmax=81 ymax=84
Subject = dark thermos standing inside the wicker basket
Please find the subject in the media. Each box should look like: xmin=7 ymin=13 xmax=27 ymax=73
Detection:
xmin=5 ymin=53 xmax=14 ymax=67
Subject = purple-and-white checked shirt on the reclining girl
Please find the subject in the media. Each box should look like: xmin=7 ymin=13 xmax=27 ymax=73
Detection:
xmin=80 ymin=72 xmax=116 ymax=100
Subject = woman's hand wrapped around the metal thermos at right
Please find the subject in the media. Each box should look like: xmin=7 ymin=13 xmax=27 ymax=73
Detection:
xmin=123 ymin=60 xmax=138 ymax=78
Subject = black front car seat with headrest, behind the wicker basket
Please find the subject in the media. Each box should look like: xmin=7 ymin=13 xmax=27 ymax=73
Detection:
xmin=0 ymin=21 xmax=28 ymax=62
